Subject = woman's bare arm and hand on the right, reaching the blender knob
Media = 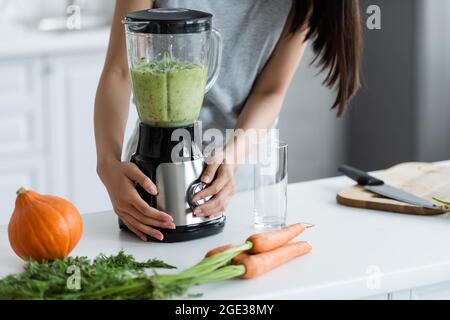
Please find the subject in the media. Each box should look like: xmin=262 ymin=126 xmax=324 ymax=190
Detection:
xmin=194 ymin=15 xmax=306 ymax=216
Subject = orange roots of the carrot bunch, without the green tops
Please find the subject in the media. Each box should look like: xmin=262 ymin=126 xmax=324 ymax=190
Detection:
xmin=206 ymin=224 xmax=312 ymax=279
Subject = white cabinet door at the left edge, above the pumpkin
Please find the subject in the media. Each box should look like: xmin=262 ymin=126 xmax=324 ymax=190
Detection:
xmin=0 ymin=58 xmax=49 ymax=223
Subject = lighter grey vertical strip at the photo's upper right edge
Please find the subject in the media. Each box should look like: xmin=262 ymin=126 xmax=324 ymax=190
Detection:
xmin=415 ymin=0 xmax=450 ymax=161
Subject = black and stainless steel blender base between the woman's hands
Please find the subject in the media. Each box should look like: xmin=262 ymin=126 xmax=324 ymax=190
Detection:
xmin=123 ymin=123 xmax=225 ymax=242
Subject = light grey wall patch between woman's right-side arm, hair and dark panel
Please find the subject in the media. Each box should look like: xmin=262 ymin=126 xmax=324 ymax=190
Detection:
xmin=279 ymin=44 xmax=346 ymax=182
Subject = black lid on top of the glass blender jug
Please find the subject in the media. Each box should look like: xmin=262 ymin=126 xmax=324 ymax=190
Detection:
xmin=124 ymin=8 xmax=212 ymax=34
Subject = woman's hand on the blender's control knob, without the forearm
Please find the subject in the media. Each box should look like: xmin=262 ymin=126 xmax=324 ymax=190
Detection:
xmin=192 ymin=152 xmax=236 ymax=217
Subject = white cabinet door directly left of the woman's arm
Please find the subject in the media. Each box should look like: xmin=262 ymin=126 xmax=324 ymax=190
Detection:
xmin=44 ymin=52 xmax=110 ymax=212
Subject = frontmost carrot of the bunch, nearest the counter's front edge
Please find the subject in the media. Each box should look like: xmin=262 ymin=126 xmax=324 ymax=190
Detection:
xmin=241 ymin=242 xmax=312 ymax=279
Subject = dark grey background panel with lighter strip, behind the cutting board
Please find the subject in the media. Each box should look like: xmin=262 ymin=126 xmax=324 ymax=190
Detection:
xmin=348 ymin=0 xmax=450 ymax=170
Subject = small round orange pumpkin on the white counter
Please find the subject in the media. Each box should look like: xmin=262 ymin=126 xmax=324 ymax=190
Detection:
xmin=8 ymin=188 xmax=83 ymax=262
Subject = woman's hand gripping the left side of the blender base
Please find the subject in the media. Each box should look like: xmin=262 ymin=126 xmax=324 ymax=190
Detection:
xmin=97 ymin=161 xmax=175 ymax=241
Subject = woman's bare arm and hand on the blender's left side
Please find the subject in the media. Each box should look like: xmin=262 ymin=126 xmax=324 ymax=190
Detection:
xmin=94 ymin=0 xmax=175 ymax=240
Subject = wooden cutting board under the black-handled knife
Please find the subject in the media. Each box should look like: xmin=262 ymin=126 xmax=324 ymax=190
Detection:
xmin=337 ymin=162 xmax=450 ymax=215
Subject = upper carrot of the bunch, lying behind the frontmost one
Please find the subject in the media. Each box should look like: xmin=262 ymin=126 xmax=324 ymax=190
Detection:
xmin=247 ymin=223 xmax=305 ymax=253
